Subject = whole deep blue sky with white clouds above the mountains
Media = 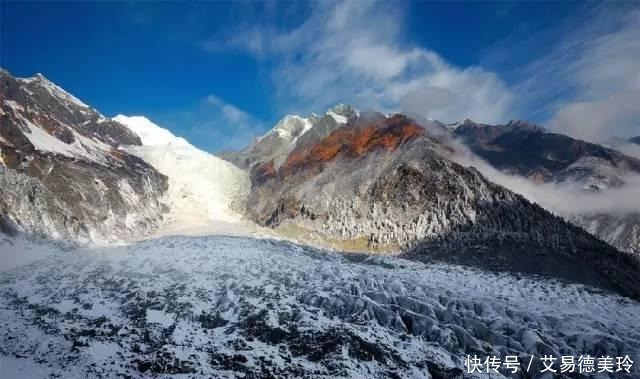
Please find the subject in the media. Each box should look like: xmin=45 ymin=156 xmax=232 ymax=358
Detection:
xmin=0 ymin=1 xmax=640 ymax=151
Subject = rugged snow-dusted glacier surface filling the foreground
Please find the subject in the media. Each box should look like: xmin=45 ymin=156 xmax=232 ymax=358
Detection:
xmin=0 ymin=237 xmax=640 ymax=379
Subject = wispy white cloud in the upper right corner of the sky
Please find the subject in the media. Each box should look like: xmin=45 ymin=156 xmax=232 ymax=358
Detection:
xmin=515 ymin=4 xmax=640 ymax=142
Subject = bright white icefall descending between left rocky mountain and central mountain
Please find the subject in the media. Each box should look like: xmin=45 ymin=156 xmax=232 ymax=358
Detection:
xmin=114 ymin=115 xmax=250 ymax=231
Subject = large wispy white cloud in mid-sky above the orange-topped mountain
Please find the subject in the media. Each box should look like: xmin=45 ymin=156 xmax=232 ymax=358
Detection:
xmin=220 ymin=1 xmax=512 ymax=122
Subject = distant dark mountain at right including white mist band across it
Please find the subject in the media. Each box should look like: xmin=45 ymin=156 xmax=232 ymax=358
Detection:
xmin=453 ymin=120 xmax=640 ymax=253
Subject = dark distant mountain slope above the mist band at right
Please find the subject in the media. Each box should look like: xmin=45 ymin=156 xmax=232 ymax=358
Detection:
xmin=454 ymin=120 xmax=640 ymax=189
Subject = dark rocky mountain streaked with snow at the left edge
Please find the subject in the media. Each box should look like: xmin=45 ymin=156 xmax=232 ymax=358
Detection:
xmin=0 ymin=71 xmax=167 ymax=243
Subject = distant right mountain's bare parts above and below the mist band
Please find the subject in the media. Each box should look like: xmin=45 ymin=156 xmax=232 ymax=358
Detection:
xmin=454 ymin=120 xmax=640 ymax=253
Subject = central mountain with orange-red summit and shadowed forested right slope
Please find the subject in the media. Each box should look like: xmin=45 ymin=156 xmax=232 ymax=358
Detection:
xmin=238 ymin=114 xmax=639 ymax=297
